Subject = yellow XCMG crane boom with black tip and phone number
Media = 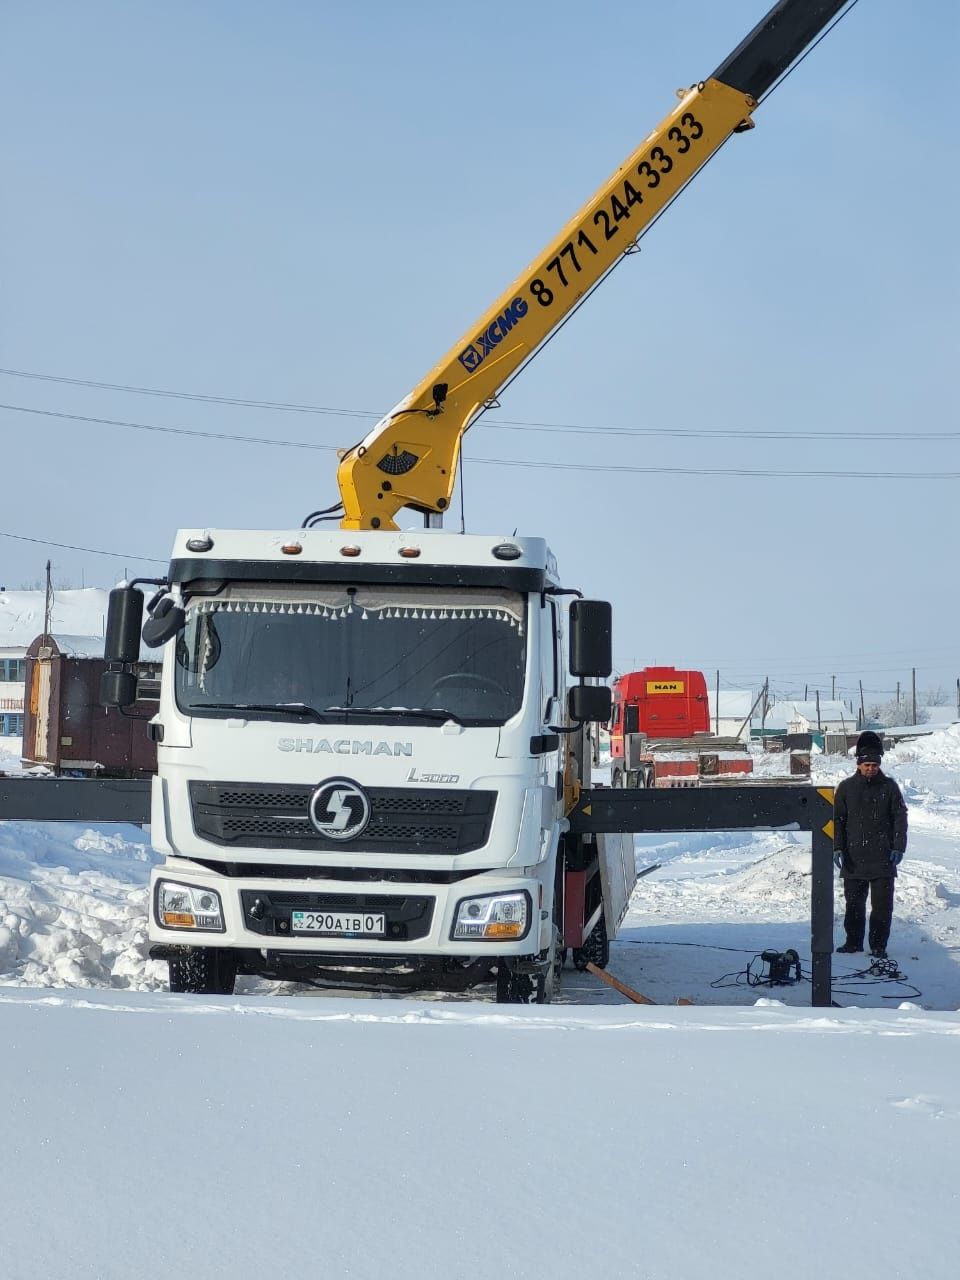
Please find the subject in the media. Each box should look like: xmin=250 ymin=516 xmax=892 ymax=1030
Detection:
xmin=337 ymin=0 xmax=847 ymax=529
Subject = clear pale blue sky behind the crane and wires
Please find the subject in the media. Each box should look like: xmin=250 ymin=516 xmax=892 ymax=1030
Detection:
xmin=0 ymin=0 xmax=960 ymax=695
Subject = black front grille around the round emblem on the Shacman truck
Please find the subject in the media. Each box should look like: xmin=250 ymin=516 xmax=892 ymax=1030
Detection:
xmin=189 ymin=782 xmax=497 ymax=855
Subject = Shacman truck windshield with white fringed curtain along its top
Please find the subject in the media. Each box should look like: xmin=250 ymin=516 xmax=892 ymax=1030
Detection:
xmin=177 ymin=584 xmax=526 ymax=724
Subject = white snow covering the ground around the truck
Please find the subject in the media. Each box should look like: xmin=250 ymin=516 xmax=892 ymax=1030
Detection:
xmin=0 ymin=727 xmax=960 ymax=1280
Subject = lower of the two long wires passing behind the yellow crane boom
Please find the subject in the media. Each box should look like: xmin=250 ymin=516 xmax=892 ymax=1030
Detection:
xmin=0 ymin=403 xmax=960 ymax=481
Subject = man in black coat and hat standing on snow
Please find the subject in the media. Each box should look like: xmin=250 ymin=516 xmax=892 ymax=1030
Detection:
xmin=833 ymin=730 xmax=906 ymax=960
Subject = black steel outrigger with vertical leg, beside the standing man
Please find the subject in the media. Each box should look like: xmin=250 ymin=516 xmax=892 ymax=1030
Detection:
xmin=568 ymin=783 xmax=833 ymax=1009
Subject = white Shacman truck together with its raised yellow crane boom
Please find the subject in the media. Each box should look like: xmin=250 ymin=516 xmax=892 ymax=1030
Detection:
xmin=101 ymin=0 xmax=846 ymax=1002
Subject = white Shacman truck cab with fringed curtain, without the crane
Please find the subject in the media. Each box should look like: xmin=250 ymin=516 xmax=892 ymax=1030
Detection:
xmin=108 ymin=529 xmax=609 ymax=1001
